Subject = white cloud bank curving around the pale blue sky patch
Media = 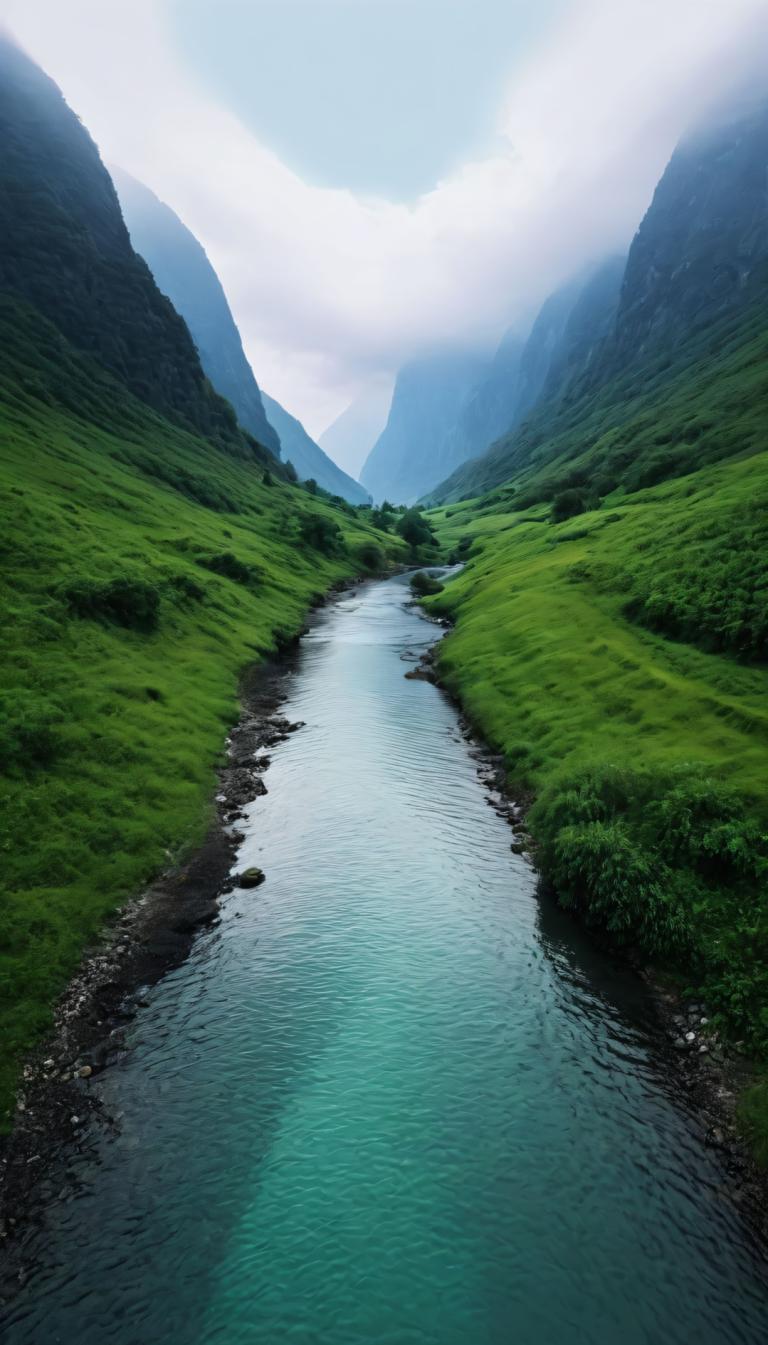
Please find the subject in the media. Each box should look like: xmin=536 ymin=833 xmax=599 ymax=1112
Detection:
xmin=3 ymin=0 xmax=767 ymax=432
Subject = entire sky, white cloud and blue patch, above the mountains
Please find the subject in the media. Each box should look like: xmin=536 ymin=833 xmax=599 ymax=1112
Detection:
xmin=0 ymin=0 xmax=768 ymax=436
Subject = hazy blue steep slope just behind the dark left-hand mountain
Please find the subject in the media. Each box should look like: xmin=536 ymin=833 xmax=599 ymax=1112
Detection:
xmin=113 ymin=169 xmax=280 ymax=457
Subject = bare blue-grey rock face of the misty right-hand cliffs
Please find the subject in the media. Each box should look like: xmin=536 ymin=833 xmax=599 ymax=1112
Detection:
xmin=430 ymin=98 xmax=768 ymax=502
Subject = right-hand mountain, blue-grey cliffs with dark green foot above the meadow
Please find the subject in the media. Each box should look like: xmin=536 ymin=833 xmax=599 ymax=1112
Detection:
xmin=430 ymin=100 xmax=768 ymax=500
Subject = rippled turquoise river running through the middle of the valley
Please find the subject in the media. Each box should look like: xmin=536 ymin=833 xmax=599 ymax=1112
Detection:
xmin=4 ymin=580 xmax=768 ymax=1345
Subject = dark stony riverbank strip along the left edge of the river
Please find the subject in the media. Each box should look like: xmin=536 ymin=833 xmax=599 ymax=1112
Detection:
xmin=0 ymin=580 xmax=362 ymax=1253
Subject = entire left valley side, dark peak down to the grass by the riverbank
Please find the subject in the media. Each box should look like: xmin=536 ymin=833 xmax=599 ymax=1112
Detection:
xmin=0 ymin=42 xmax=395 ymax=1130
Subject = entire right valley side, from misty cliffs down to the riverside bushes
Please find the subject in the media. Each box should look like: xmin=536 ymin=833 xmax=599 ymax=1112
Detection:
xmin=419 ymin=94 xmax=768 ymax=1157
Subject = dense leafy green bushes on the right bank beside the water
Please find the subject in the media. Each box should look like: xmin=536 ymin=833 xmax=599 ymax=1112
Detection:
xmin=530 ymin=767 xmax=768 ymax=1050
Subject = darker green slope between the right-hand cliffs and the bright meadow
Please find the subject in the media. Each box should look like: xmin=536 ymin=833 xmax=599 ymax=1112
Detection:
xmin=433 ymin=305 xmax=768 ymax=504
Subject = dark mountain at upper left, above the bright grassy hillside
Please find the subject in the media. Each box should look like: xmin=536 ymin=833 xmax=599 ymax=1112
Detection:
xmin=0 ymin=34 xmax=262 ymax=456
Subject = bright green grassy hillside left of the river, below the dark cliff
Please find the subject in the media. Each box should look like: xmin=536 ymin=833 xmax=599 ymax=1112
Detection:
xmin=0 ymin=300 xmax=404 ymax=1119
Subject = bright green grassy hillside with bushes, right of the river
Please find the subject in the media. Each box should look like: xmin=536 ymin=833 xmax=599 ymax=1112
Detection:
xmin=426 ymin=441 xmax=768 ymax=1154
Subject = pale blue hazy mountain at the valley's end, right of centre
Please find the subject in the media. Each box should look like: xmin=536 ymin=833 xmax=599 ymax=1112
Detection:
xmin=360 ymin=351 xmax=488 ymax=504
